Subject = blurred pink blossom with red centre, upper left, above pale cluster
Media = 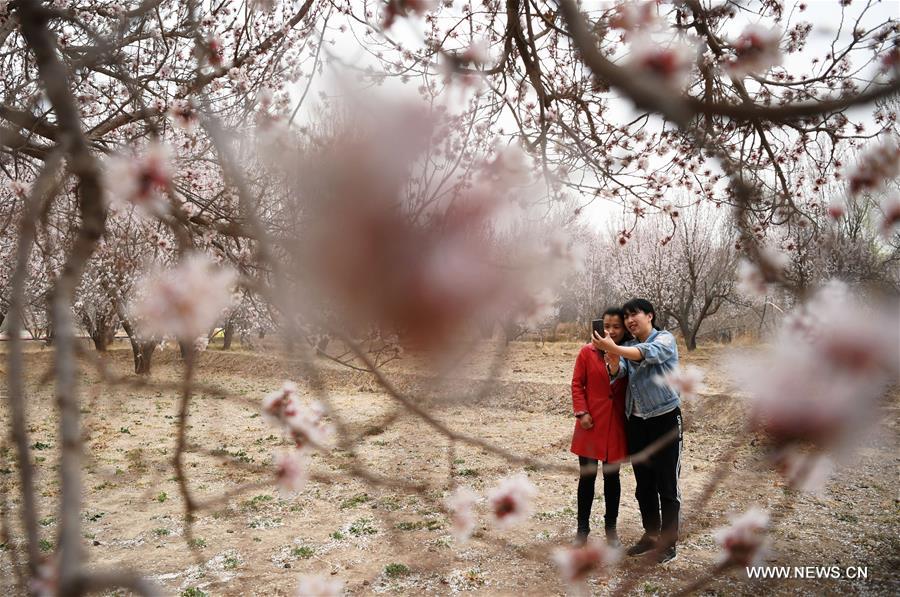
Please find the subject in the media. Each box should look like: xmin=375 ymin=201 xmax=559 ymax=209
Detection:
xmin=104 ymin=142 xmax=172 ymax=215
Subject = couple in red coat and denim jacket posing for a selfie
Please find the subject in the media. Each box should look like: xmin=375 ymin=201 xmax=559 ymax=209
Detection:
xmin=572 ymin=299 xmax=682 ymax=564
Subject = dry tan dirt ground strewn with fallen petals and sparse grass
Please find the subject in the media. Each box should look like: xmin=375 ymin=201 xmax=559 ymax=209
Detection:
xmin=0 ymin=342 xmax=900 ymax=595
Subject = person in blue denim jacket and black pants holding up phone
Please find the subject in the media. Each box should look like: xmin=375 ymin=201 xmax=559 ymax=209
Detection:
xmin=593 ymin=299 xmax=682 ymax=563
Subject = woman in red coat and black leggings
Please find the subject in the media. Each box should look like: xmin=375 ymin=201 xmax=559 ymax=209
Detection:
xmin=572 ymin=308 xmax=631 ymax=547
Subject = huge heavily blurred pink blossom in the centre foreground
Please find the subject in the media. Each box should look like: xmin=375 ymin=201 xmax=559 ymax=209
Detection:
xmin=298 ymin=109 xmax=565 ymax=349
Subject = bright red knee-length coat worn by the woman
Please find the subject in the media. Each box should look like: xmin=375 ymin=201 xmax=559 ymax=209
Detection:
xmin=572 ymin=344 xmax=628 ymax=462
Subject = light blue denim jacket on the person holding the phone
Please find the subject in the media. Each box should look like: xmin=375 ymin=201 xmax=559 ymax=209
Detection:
xmin=615 ymin=330 xmax=681 ymax=419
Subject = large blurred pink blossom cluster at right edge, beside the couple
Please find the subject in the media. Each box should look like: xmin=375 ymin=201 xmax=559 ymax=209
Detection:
xmin=732 ymin=282 xmax=900 ymax=451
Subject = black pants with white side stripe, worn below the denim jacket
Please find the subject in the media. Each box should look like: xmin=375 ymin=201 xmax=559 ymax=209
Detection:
xmin=627 ymin=408 xmax=682 ymax=545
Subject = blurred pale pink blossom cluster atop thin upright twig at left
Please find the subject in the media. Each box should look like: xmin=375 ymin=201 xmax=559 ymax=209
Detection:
xmin=131 ymin=253 xmax=237 ymax=341
